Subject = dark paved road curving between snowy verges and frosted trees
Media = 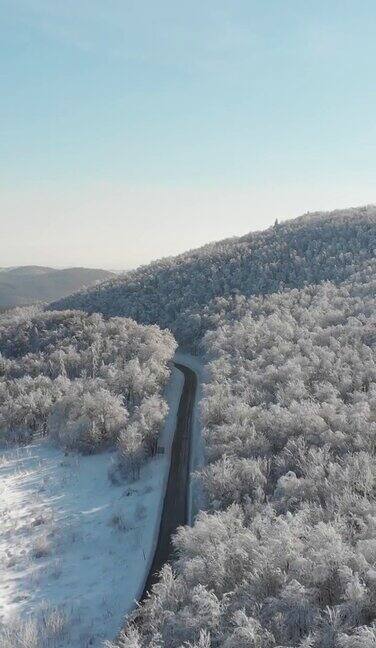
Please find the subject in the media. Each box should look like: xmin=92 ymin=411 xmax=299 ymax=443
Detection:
xmin=140 ymin=363 xmax=197 ymax=602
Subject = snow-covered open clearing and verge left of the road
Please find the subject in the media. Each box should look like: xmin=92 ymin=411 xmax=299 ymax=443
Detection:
xmin=0 ymin=369 xmax=183 ymax=648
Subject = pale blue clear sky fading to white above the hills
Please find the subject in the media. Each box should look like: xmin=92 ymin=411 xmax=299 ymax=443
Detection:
xmin=0 ymin=0 xmax=376 ymax=269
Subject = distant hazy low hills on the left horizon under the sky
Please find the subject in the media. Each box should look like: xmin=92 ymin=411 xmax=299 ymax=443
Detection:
xmin=0 ymin=266 xmax=116 ymax=310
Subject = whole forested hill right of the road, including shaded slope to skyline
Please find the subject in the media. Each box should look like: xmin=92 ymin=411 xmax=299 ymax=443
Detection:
xmin=47 ymin=207 xmax=376 ymax=648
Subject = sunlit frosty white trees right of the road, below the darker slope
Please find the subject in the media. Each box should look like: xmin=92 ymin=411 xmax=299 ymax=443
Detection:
xmin=114 ymin=268 xmax=376 ymax=648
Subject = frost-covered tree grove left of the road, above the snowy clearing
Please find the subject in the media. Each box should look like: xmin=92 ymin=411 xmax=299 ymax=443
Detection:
xmin=0 ymin=307 xmax=176 ymax=469
